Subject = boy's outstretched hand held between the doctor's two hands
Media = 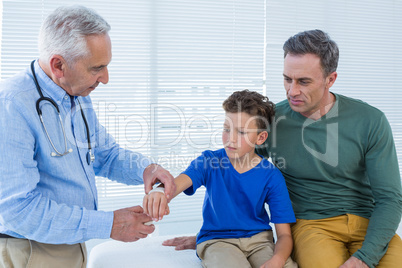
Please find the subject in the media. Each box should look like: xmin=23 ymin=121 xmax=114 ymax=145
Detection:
xmin=142 ymin=189 xmax=170 ymax=221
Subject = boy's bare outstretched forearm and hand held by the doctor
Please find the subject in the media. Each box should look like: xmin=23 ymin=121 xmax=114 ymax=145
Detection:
xmin=142 ymin=174 xmax=193 ymax=221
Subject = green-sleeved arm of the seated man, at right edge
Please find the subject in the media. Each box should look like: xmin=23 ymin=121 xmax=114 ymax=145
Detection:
xmin=353 ymin=115 xmax=402 ymax=267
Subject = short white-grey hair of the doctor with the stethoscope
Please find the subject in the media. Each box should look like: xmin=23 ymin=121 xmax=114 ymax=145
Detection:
xmin=39 ymin=5 xmax=110 ymax=67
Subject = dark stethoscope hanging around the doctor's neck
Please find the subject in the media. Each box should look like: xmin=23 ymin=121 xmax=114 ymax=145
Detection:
xmin=31 ymin=61 xmax=95 ymax=165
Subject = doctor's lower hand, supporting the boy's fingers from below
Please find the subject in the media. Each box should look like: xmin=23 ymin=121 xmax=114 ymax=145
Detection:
xmin=110 ymin=206 xmax=155 ymax=242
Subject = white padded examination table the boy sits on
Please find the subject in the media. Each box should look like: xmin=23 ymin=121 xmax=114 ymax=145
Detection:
xmin=87 ymin=235 xmax=202 ymax=268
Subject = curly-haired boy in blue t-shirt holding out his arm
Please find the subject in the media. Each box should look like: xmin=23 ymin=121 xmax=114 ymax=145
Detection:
xmin=143 ymin=90 xmax=297 ymax=268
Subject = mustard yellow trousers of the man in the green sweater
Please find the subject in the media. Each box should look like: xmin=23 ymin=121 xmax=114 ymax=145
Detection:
xmin=292 ymin=214 xmax=402 ymax=268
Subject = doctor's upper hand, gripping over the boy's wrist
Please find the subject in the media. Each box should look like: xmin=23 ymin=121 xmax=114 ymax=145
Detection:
xmin=143 ymin=164 xmax=176 ymax=202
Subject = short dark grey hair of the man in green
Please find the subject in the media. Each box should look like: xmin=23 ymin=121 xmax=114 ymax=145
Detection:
xmin=283 ymin=30 xmax=339 ymax=76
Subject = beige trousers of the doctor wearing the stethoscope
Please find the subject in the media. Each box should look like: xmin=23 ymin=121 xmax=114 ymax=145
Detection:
xmin=0 ymin=238 xmax=87 ymax=268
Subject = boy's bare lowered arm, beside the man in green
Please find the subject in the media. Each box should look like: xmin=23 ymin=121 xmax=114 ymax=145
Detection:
xmin=261 ymin=223 xmax=293 ymax=268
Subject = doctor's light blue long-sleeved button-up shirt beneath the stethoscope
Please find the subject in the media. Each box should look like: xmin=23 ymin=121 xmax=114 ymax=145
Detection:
xmin=0 ymin=61 xmax=151 ymax=244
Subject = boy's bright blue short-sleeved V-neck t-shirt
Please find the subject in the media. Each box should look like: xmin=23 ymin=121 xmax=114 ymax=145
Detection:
xmin=183 ymin=149 xmax=296 ymax=244
